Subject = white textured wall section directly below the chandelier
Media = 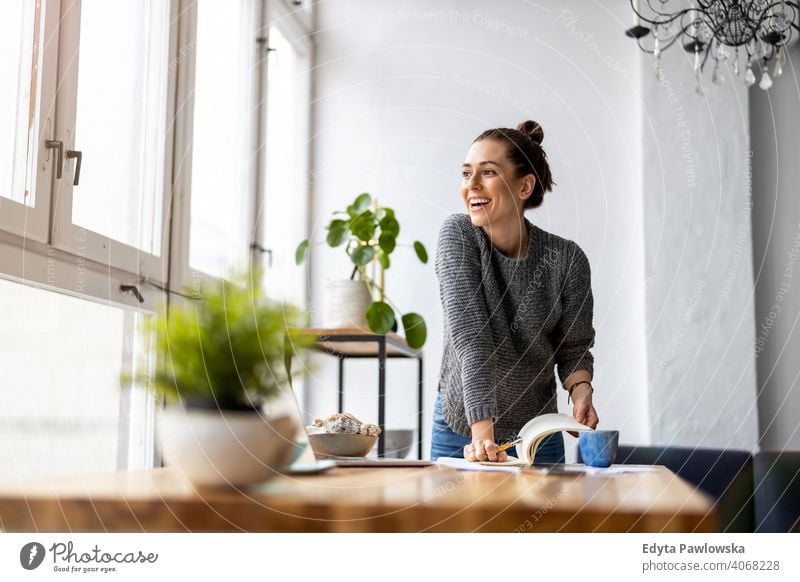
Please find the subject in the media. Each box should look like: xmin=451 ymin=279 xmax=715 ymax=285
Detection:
xmin=642 ymin=34 xmax=757 ymax=449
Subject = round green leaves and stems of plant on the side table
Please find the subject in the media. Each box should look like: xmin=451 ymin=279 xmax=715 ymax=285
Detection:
xmin=295 ymin=193 xmax=428 ymax=349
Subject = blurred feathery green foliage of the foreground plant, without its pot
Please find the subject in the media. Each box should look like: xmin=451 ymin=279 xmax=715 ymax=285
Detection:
xmin=128 ymin=271 xmax=313 ymax=409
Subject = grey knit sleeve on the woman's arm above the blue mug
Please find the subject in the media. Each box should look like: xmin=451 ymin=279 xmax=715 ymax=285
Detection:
xmin=554 ymin=243 xmax=595 ymax=388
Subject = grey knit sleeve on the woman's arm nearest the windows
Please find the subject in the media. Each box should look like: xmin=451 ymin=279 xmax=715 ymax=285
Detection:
xmin=435 ymin=215 xmax=497 ymax=425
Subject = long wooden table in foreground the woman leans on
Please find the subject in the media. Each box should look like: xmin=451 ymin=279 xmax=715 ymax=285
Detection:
xmin=0 ymin=466 xmax=715 ymax=532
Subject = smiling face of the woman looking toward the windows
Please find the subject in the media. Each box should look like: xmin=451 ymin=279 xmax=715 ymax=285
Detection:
xmin=461 ymin=139 xmax=534 ymax=227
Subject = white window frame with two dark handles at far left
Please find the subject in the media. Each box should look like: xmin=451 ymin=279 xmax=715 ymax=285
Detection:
xmin=0 ymin=0 xmax=182 ymax=312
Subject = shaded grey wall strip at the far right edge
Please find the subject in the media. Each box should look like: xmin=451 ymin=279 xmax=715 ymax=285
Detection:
xmin=750 ymin=43 xmax=800 ymax=450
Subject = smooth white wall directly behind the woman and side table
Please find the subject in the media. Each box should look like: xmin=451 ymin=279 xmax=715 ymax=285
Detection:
xmin=307 ymin=0 xmax=649 ymax=451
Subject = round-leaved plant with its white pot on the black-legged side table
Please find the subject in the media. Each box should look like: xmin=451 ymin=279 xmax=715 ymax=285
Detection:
xmin=295 ymin=193 xmax=428 ymax=349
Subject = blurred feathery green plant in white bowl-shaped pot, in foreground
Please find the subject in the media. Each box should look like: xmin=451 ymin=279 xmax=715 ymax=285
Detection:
xmin=125 ymin=272 xmax=311 ymax=486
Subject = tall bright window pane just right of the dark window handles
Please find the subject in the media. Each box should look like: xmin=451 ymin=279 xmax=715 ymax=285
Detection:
xmin=65 ymin=0 xmax=169 ymax=255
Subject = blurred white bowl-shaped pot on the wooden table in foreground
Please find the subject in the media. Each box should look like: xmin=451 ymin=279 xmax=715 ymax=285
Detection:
xmin=158 ymin=407 xmax=296 ymax=487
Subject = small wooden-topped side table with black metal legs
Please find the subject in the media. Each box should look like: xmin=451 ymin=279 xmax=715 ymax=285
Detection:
xmin=291 ymin=327 xmax=423 ymax=459
